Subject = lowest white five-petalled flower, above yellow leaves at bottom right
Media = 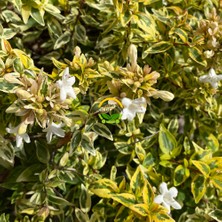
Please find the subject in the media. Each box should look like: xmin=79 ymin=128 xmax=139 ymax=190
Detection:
xmin=154 ymin=182 xmax=181 ymax=213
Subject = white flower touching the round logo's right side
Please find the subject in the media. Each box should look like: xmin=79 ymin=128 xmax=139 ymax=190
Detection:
xmin=121 ymin=97 xmax=146 ymax=121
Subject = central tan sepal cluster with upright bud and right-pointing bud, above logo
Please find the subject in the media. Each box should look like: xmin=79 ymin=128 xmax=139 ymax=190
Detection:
xmin=107 ymin=44 xmax=174 ymax=102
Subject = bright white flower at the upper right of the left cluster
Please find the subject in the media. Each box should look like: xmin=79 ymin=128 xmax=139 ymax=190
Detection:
xmin=57 ymin=67 xmax=76 ymax=101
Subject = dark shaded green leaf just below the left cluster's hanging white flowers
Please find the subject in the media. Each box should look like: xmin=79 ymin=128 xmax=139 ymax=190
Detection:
xmin=35 ymin=140 xmax=50 ymax=164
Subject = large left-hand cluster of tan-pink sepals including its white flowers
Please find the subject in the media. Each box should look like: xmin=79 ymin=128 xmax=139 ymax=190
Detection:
xmin=4 ymin=67 xmax=76 ymax=147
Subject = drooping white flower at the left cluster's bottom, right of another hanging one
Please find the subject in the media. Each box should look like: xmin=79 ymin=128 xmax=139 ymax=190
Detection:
xmin=43 ymin=122 xmax=65 ymax=143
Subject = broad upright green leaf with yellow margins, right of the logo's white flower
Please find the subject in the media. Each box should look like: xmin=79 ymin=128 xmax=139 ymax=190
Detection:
xmin=158 ymin=124 xmax=177 ymax=155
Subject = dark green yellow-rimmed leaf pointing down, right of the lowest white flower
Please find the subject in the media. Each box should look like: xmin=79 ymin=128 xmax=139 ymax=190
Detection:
xmin=191 ymin=174 xmax=207 ymax=204
